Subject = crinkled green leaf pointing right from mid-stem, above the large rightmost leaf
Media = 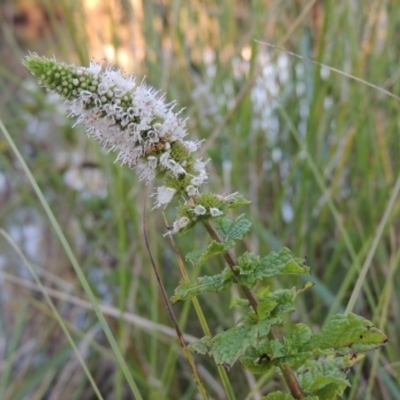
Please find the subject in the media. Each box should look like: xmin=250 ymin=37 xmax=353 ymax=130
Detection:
xmin=235 ymin=247 xmax=310 ymax=289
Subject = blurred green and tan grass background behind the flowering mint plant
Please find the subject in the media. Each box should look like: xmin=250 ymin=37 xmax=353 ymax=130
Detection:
xmin=0 ymin=0 xmax=400 ymax=400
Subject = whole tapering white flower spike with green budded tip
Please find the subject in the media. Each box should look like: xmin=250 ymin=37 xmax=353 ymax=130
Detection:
xmin=25 ymin=54 xmax=228 ymax=234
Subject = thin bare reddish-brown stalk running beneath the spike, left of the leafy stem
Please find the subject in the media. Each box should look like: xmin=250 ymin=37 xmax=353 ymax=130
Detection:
xmin=143 ymin=197 xmax=209 ymax=400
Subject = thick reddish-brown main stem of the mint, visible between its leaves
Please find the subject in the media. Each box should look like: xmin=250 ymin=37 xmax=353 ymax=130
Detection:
xmin=203 ymin=222 xmax=304 ymax=400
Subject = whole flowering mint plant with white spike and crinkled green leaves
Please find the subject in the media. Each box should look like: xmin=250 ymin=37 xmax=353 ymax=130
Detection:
xmin=24 ymin=54 xmax=387 ymax=400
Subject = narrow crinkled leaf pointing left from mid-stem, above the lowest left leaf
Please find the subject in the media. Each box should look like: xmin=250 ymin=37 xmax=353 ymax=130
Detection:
xmin=171 ymin=268 xmax=233 ymax=304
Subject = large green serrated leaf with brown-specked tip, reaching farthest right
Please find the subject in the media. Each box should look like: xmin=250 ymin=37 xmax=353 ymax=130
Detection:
xmin=304 ymin=314 xmax=388 ymax=354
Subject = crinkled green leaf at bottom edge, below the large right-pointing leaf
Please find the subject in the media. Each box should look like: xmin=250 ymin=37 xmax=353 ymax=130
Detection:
xmin=298 ymin=357 xmax=350 ymax=400
